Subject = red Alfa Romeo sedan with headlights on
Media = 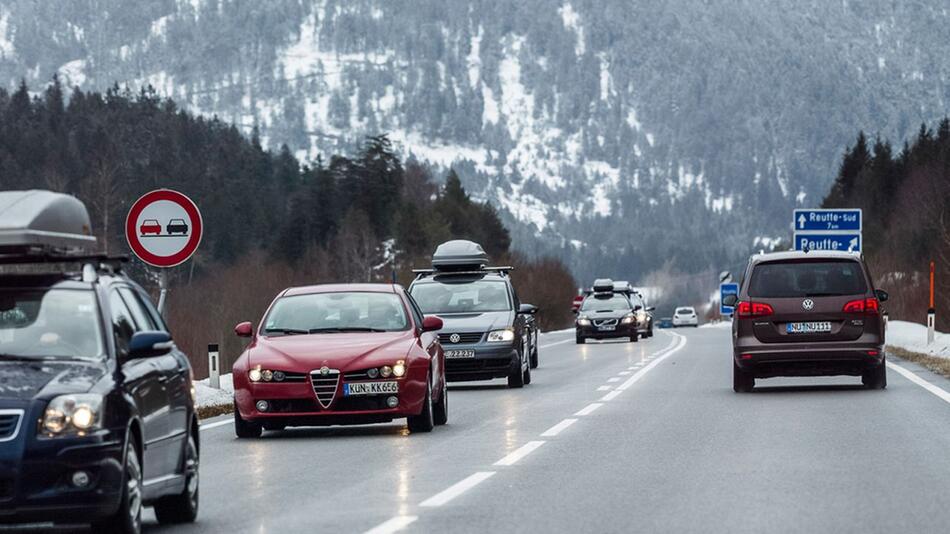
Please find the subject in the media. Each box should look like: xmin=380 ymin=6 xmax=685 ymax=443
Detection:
xmin=233 ymin=284 xmax=448 ymax=438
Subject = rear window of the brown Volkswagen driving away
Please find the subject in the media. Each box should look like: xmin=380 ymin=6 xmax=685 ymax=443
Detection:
xmin=749 ymin=260 xmax=867 ymax=298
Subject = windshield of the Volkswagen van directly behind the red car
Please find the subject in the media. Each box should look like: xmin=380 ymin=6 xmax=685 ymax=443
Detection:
xmin=411 ymin=280 xmax=511 ymax=314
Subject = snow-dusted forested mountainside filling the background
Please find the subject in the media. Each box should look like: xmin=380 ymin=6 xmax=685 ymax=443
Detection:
xmin=0 ymin=0 xmax=950 ymax=278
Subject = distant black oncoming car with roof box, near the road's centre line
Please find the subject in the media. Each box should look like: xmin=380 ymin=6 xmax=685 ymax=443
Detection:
xmin=574 ymin=292 xmax=639 ymax=344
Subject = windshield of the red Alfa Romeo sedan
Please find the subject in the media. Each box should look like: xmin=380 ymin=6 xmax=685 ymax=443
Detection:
xmin=264 ymin=292 xmax=409 ymax=335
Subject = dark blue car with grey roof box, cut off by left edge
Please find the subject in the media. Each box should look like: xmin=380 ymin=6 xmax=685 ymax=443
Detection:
xmin=0 ymin=192 xmax=199 ymax=533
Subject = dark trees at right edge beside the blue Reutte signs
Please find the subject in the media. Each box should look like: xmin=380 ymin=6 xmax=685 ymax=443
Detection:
xmin=822 ymin=119 xmax=950 ymax=331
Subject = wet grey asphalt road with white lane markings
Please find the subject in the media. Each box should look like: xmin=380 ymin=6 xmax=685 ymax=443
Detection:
xmin=145 ymin=328 xmax=950 ymax=534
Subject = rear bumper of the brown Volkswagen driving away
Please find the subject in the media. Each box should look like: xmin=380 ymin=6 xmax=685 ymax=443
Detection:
xmin=733 ymin=343 xmax=884 ymax=378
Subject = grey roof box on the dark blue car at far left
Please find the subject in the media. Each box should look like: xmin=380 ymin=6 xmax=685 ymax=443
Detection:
xmin=0 ymin=189 xmax=96 ymax=254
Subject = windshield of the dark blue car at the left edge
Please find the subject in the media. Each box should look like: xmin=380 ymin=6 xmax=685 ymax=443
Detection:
xmin=0 ymin=289 xmax=105 ymax=359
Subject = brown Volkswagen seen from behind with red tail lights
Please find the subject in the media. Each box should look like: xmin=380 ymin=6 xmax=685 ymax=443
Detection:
xmin=726 ymin=252 xmax=887 ymax=392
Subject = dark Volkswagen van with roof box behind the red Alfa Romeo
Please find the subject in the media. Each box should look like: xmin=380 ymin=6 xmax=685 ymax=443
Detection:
xmin=409 ymin=240 xmax=538 ymax=388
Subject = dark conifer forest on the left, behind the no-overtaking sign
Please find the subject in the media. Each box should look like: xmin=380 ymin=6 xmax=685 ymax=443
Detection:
xmin=0 ymin=79 xmax=576 ymax=376
